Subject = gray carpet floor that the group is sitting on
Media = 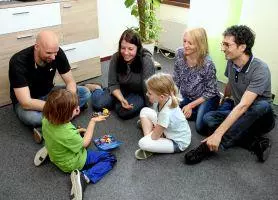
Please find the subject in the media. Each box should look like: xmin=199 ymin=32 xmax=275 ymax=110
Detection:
xmin=0 ymin=50 xmax=278 ymax=200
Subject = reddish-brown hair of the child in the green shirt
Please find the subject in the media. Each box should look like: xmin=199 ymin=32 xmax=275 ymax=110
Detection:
xmin=43 ymin=89 xmax=78 ymax=125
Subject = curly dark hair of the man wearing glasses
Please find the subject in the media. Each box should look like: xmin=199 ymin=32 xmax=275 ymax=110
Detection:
xmin=223 ymin=25 xmax=255 ymax=55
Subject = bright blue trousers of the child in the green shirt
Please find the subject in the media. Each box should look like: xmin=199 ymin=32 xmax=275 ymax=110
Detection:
xmin=82 ymin=150 xmax=117 ymax=183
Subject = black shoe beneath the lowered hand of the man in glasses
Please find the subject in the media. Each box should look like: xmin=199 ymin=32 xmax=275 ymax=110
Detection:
xmin=184 ymin=143 xmax=213 ymax=165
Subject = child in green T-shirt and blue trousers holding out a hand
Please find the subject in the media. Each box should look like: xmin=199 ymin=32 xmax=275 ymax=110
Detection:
xmin=39 ymin=89 xmax=116 ymax=199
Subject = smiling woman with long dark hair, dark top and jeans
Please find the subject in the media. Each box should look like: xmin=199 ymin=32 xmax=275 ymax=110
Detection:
xmin=85 ymin=29 xmax=155 ymax=119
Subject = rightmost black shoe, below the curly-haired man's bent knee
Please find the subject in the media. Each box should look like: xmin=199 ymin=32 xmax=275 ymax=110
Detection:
xmin=251 ymin=137 xmax=271 ymax=162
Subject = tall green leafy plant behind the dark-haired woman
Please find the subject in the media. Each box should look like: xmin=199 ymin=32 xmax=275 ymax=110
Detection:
xmin=125 ymin=0 xmax=161 ymax=44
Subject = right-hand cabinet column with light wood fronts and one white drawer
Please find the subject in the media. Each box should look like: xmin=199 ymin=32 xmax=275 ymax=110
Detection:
xmin=55 ymin=0 xmax=101 ymax=84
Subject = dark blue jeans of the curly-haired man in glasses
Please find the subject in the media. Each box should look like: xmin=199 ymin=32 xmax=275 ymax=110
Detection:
xmin=203 ymin=99 xmax=275 ymax=149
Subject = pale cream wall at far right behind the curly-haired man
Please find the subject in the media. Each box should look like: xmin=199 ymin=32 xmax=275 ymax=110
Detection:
xmin=240 ymin=0 xmax=278 ymax=103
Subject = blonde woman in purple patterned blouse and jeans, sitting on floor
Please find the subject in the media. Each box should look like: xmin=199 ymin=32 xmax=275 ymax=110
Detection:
xmin=174 ymin=28 xmax=220 ymax=134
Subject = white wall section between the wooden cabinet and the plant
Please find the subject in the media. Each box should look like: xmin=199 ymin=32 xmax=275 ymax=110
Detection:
xmin=97 ymin=0 xmax=137 ymax=58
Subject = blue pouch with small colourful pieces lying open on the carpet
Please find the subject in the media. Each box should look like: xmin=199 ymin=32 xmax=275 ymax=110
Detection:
xmin=94 ymin=135 xmax=122 ymax=151
